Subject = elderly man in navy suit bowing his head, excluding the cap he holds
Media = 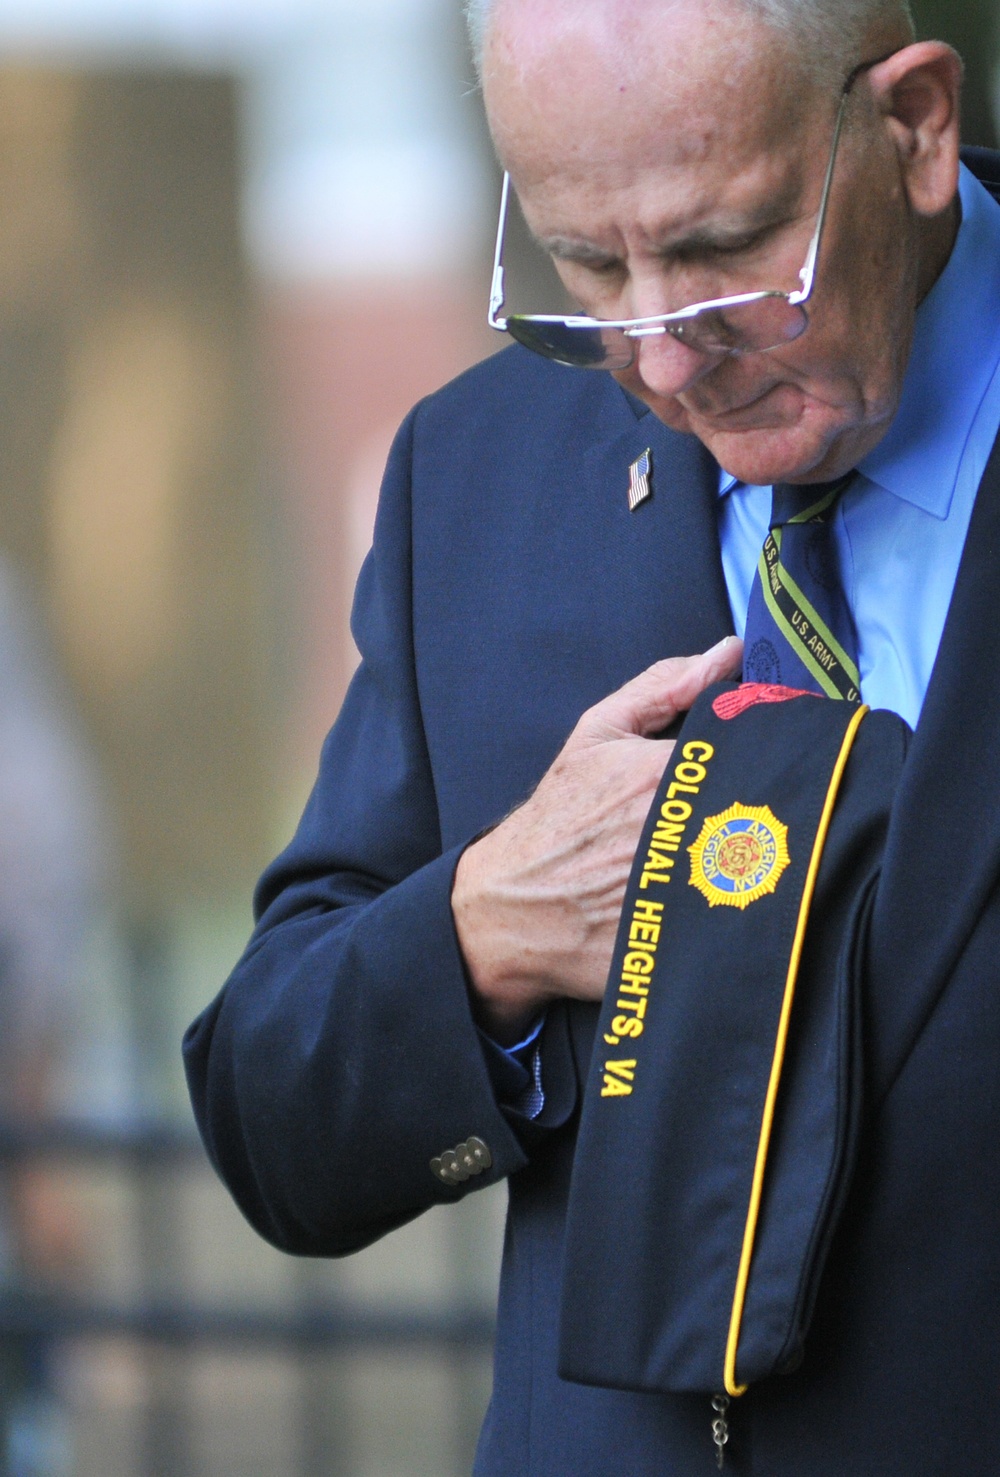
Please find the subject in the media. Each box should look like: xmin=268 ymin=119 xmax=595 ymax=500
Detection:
xmin=188 ymin=0 xmax=1000 ymax=1477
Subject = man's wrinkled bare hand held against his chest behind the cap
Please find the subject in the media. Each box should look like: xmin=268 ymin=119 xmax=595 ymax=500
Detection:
xmin=452 ymin=637 xmax=743 ymax=1043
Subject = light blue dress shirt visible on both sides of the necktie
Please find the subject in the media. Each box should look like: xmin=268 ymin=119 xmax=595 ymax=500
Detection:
xmin=719 ymin=165 xmax=1000 ymax=727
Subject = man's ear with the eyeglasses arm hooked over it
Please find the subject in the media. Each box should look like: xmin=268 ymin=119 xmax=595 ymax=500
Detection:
xmin=869 ymin=41 xmax=962 ymax=216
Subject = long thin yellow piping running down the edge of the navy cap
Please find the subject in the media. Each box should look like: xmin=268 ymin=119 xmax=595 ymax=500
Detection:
xmin=724 ymin=706 xmax=870 ymax=1396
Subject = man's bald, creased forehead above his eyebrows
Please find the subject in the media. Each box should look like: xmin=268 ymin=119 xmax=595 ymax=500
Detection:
xmin=483 ymin=0 xmax=835 ymax=233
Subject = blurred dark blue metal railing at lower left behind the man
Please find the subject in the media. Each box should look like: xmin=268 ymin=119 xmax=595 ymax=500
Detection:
xmin=0 ymin=1121 xmax=493 ymax=1477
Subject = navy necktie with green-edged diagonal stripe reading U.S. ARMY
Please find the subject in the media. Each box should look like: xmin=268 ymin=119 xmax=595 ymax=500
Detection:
xmin=743 ymin=471 xmax=861 ymax=703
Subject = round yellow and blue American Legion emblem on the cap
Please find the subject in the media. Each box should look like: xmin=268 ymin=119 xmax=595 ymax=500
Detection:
xmin=688 ymin=802 xmax=789 ymax=908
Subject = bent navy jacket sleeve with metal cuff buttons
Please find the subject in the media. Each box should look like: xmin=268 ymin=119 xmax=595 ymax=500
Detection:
xmin=185 ymin=411 xmax=573 ymax=1255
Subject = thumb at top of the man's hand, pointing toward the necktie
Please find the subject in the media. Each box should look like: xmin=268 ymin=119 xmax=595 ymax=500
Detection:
xmin=573 ymin=637 xmax=743 ymax=743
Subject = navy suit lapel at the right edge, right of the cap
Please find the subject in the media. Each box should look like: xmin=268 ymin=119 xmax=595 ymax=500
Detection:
xmin=870 ymin=425 xmax=1000 ymax=1096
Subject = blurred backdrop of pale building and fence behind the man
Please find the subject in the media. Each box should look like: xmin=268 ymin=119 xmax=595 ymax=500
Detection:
xmin=0 ymin=0 xmax=999 ymax=1477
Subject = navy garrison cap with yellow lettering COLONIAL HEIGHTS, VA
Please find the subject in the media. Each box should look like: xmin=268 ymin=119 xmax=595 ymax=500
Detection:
xmin=560 ymin=682 xmax=910 ymax=1396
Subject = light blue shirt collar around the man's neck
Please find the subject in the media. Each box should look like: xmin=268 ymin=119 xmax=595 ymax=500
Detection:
xmin=719 ymin=164 xmax=1000 ymax=518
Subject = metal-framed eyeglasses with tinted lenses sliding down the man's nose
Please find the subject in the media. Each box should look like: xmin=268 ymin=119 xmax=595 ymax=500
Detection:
xmin=486 ymin=52 xmax=894 ymax=369
